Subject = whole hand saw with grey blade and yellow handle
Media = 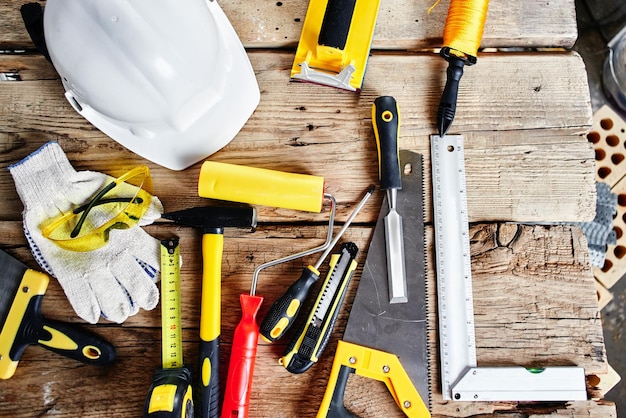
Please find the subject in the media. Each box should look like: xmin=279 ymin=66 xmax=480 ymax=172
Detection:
xmin=317 ymin=150 xmax=430 ymax=417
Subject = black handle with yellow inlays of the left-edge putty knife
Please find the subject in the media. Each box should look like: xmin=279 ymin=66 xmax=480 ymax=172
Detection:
xmin=9 ymin=295 xmax=115 ymax=366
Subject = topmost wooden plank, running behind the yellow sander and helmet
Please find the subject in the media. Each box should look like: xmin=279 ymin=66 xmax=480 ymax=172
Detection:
xmin=0 ymin=0 xmax=577 ymax=50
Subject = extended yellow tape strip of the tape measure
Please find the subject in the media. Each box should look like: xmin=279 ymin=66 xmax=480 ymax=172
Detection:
xmin=161 ymin=238 xmax=183 ymax=369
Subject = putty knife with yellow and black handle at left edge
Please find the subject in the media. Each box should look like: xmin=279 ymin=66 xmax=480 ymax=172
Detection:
xmin=0 ymin=250 xmax=115 ymax=379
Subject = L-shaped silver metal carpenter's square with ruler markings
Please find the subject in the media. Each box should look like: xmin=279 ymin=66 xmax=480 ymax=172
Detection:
xmin=430 ymin=135 xmax=587 ymax=401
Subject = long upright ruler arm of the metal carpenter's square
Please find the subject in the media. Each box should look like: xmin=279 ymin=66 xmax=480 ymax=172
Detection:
xmin=430 ymin=135 xmax=476 ymax=400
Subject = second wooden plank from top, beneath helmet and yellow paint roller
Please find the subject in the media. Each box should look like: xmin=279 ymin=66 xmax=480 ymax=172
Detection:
xmin=0 ymin=51 xmax=595 ymax=222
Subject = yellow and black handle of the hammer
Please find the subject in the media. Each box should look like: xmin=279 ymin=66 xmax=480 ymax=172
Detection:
xmin=196 ymin=232 xmax=224 ymax=418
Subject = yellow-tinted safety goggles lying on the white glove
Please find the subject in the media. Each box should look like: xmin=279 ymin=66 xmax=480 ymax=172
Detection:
xmin=40 ymin=166 xmax=152 ymax=252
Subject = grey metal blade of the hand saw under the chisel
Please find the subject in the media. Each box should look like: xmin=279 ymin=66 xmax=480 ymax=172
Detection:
xmin=343 ymin=150 xmax=430 ymax=406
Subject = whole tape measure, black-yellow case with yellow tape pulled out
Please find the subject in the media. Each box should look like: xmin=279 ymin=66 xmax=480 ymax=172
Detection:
xmin=143 ymin=238 xmax=194 ymax=418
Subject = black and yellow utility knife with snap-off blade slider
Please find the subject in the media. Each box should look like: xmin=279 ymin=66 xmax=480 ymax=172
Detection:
xmin=279 ymin=242 xmax=359 ymax=373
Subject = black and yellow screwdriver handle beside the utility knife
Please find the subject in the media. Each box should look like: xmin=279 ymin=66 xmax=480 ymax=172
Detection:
xmin=261 ymin=266 xmax=320 ymax=342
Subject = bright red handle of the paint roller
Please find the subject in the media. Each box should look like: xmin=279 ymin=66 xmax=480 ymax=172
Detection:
xmin=221 ymin=294 xmax=263 ymax=418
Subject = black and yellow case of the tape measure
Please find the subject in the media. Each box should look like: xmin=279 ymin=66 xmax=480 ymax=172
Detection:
xmin=143 ymin=367 xmax=194 ymax=418
